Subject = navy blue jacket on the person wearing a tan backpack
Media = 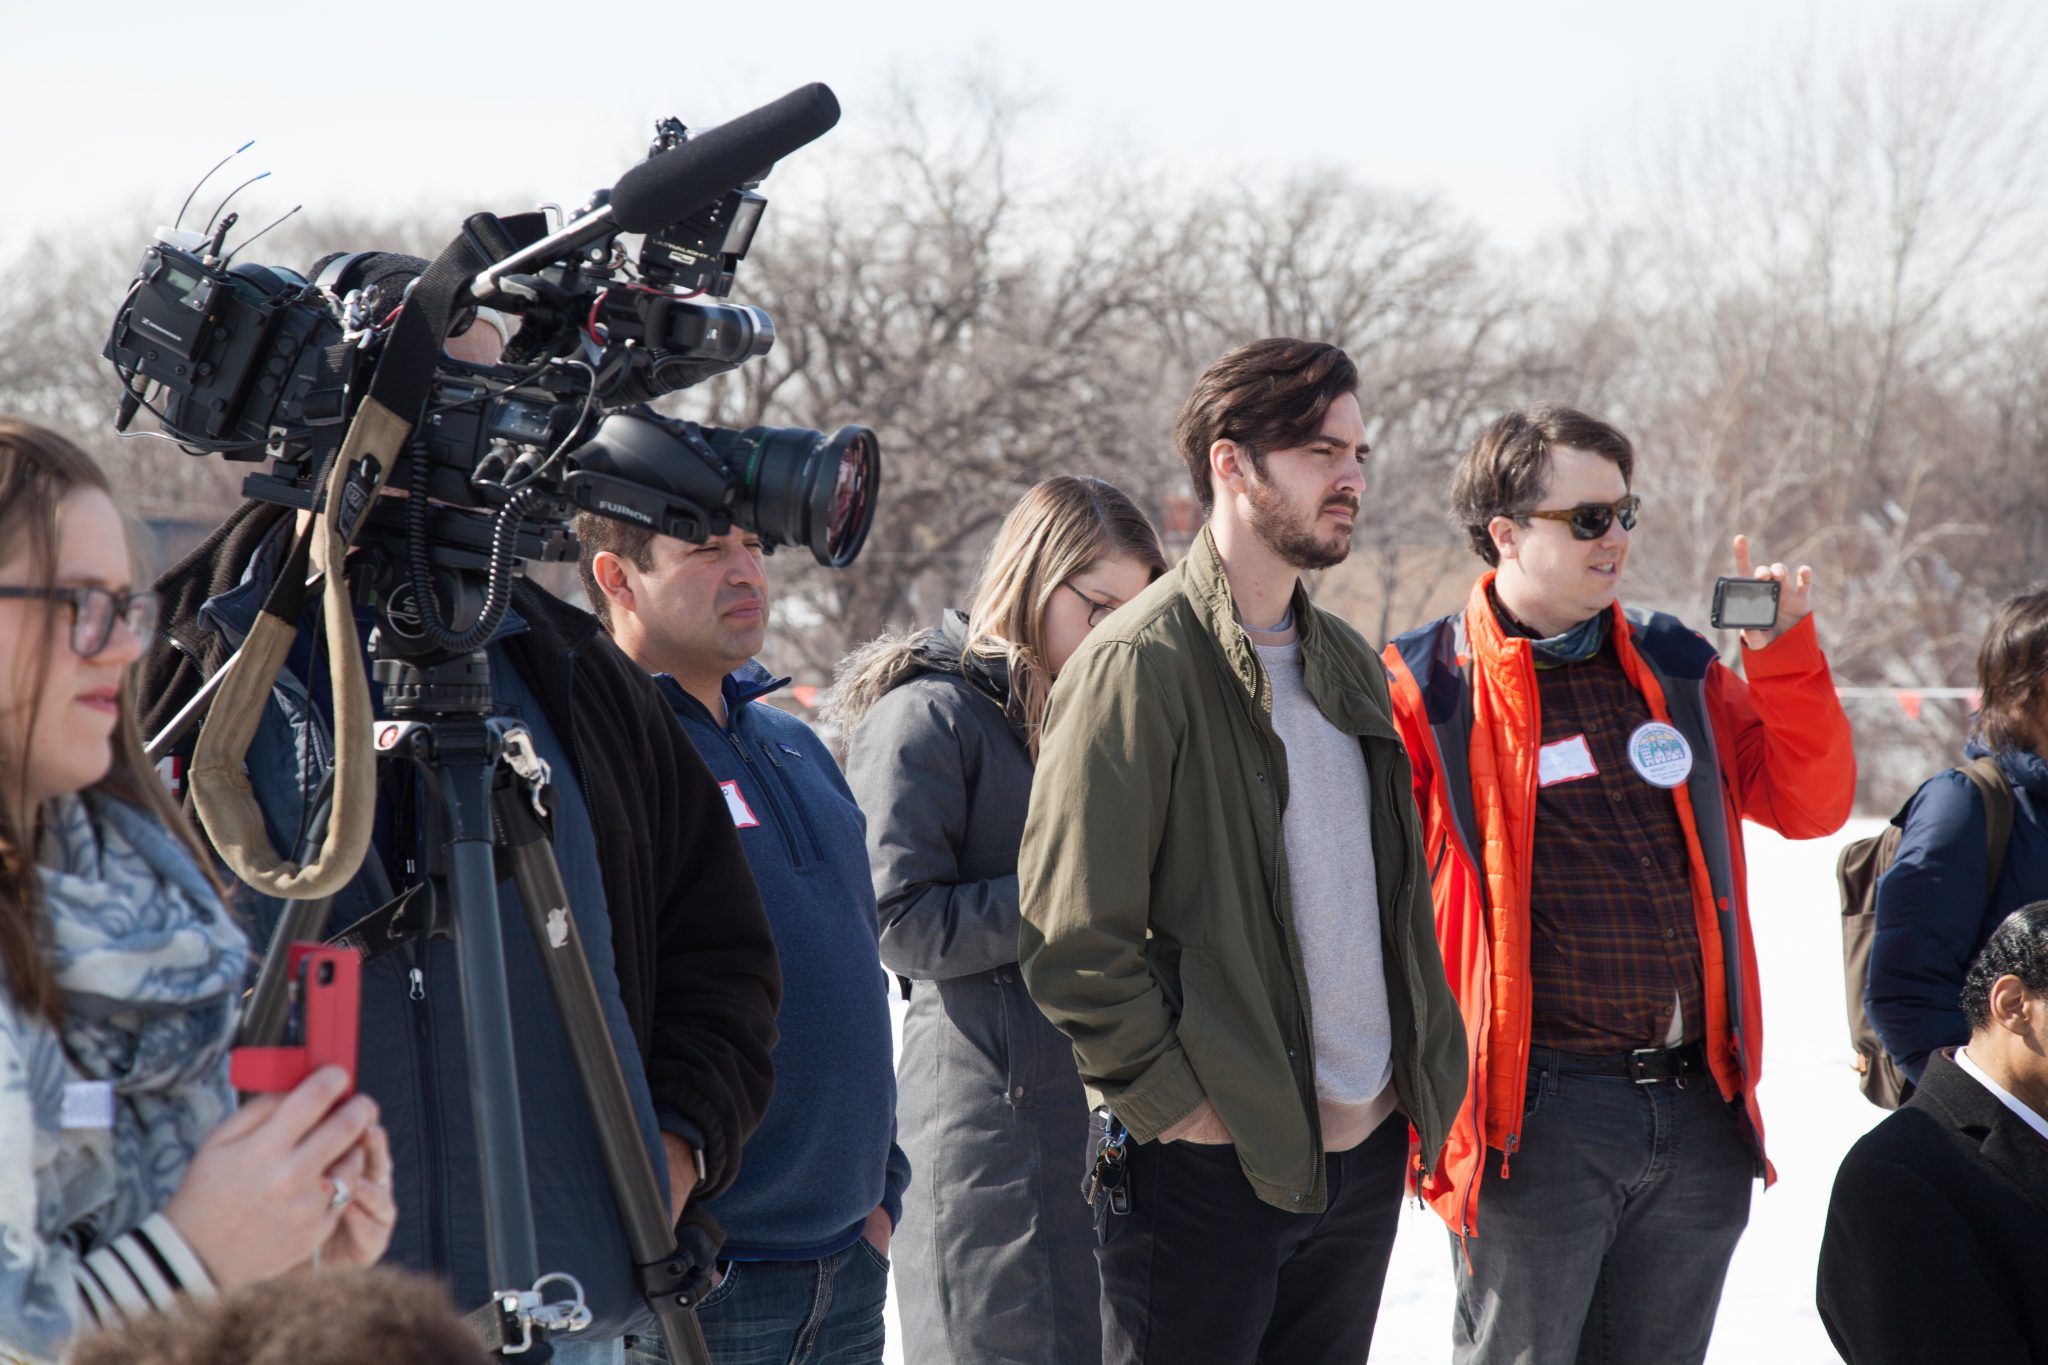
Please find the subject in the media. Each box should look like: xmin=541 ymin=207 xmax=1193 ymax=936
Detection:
xmin=1864 ymin=745 xmax=2048 ymax=1081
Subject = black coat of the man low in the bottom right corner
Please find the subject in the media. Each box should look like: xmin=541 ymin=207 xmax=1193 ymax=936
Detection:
xmin=1817 ymin=1052 xmax=2048 ymax=1365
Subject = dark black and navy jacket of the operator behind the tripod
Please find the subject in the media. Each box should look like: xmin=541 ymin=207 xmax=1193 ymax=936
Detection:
xmin=141 ymin=505 xmax=780 ymax=1334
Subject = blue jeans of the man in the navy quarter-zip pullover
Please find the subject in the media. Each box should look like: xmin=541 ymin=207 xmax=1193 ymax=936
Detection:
xmin=625 ymin=1238 xmax=889 ymax=1365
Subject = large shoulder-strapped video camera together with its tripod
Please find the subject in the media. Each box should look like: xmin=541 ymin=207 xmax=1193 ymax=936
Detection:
xmin=104 ymin=86 xmax=879 ymax=1365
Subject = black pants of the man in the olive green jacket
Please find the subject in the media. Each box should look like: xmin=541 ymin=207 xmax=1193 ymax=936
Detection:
xmin=1096 ymin=1113 xmax=1407 ymax=1365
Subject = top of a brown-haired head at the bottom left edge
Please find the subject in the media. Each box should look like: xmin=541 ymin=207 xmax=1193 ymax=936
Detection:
xmin=66 ymin=1267 xmax=491 ymax=1365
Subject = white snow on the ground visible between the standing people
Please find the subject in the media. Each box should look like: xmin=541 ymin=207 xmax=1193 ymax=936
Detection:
xmin=887 ymin=821 xmax=1884 ymax=1365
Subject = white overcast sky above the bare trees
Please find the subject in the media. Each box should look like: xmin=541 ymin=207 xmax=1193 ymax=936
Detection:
xmin=0 ymin=0 xmax=1966 ymax=268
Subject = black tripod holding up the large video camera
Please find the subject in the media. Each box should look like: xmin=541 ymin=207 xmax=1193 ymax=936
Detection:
xmin=201 ymin=540 xmax=713 ymax=1365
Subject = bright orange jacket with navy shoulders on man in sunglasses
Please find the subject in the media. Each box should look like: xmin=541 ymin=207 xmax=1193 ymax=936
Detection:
xmin=1384 ymin=573 xmax=1855 ymax=1236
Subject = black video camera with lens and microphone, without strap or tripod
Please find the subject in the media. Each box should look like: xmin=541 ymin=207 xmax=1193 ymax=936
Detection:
xmin=104 ymin=77 xmax=879 ymax=593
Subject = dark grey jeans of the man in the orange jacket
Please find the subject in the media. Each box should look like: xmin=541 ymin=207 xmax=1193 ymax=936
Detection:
xmin=1450 ymin=1048 xmax=1757 ymax=1365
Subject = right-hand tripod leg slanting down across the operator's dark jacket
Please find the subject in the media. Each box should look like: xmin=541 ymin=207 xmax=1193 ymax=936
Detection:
xmin=496 ymin=782 xmax=711 ymax=1365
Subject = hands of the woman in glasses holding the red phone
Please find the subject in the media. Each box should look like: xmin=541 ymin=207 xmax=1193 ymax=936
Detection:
xmin=164 ymin=1066 xmax=389 ymax=1289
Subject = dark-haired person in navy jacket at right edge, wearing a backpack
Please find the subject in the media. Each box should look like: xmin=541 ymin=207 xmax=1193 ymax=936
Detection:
xmin=1864 ymin=585 xmax=2048 ymax=1083
